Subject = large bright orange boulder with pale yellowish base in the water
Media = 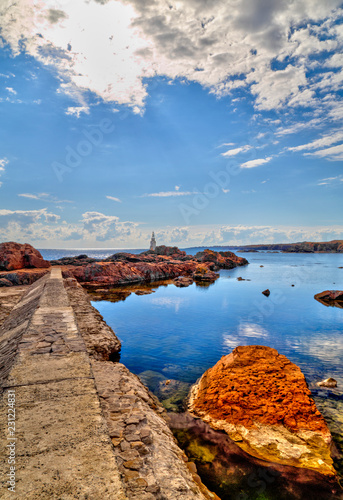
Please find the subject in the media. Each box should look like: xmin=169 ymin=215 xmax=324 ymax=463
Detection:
xmin=189 ymin=346 xmax=335 ymax=475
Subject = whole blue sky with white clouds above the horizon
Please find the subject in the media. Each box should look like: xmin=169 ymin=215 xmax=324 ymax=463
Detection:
xmin=0 ymin=0 xmax=343 ymax=248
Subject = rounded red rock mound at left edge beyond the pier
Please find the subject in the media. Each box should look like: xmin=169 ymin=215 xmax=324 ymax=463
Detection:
xmin=0 ymin=241 xmax=50 ymax=271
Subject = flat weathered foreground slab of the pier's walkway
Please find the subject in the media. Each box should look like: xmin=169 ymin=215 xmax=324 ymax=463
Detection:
xmin=0 ymin=379 xmax=126 ymax=500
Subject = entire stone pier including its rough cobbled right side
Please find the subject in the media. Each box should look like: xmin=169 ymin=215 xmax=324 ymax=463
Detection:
xmin=0 ymin=267 xmax=216 ymax=500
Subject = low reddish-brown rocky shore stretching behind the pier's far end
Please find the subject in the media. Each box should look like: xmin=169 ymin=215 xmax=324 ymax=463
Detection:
xmin=0 ymin=243 xmax=248 ymax=289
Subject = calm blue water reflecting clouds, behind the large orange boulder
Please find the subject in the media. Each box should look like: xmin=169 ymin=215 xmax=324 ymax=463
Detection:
xmin=94 ymin=253 xmax=343 ymax=387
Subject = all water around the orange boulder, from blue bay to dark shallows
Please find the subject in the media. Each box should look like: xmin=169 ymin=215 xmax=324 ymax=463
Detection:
xmin=94 ymin=253 xmax=343 ymax=500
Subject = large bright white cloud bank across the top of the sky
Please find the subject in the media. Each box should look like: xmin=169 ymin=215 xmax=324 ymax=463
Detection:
xmin=0 ymin=0 xmax=343 ymax=116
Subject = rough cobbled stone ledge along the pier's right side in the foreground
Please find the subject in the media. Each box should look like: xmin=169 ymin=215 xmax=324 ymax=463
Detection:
xmin=92 ymin=361 xmax=214 ymax=500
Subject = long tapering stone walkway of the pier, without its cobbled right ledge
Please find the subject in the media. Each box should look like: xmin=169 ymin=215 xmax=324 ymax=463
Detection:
xmin=0 ymin=268 xmax=127 ymax=500
